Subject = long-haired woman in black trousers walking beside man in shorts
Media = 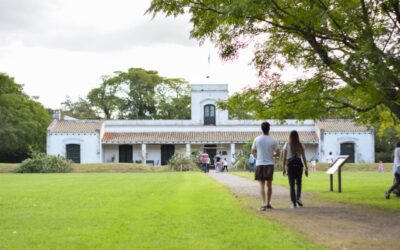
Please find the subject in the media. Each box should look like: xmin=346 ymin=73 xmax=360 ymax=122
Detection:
xmin=283 ymin=130 xmax=308 ymax=208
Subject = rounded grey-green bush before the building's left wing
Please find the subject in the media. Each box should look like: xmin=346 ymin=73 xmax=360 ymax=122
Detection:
xmin=17 ymin=153 xmax=72 ymax=173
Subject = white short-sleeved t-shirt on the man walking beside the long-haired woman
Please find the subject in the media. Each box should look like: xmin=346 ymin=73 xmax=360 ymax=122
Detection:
xmin=251 ymin=135 xmax=279 ymax=166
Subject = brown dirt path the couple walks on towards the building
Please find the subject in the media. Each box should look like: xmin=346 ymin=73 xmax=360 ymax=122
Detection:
xmin=209 ymin=173 xmax=400 ymax=249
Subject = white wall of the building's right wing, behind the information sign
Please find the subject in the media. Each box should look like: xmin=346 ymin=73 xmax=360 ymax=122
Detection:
xmin=319 ymin=132 xmax=375 ymax=163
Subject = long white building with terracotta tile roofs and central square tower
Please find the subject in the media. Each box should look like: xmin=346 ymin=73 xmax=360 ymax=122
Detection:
xmin=47 ymin=84 xmax=375 ymax=165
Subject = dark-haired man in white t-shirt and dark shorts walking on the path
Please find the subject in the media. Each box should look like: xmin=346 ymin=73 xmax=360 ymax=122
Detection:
xmin=251 ymin=122 xmax=280 ymax=211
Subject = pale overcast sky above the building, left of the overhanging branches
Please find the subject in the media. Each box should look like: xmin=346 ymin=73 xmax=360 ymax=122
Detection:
xmin=0 ymin=0 xmax=302 ymax=108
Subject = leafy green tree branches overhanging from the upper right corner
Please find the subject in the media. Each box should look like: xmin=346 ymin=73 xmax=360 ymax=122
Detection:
xmin=148 ymin=0 xmax=400 ymax=124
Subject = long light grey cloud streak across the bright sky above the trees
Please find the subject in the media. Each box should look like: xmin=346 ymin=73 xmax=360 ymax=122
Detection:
xmin=34 ymin=20 xmax=197 ymax=52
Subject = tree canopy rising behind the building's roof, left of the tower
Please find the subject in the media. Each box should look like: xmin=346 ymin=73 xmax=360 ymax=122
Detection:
xmin=63 ymin=68 xmax=190 ymax=120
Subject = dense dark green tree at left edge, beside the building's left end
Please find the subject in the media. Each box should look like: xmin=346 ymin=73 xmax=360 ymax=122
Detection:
xmin=0 ymin=73 xmax=51 ymax=162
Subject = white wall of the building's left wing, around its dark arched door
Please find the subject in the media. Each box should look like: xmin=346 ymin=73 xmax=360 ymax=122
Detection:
xmin=47 ymin=132 xmax=102 ymax=163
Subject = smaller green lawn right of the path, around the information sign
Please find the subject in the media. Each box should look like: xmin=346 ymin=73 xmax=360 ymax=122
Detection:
xmin=234 ymin=170 xmax=400 ymax=211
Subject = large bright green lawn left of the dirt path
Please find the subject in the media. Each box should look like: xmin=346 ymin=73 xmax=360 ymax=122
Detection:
xmin=0 ymin=172 xmax=321 ymax=249
